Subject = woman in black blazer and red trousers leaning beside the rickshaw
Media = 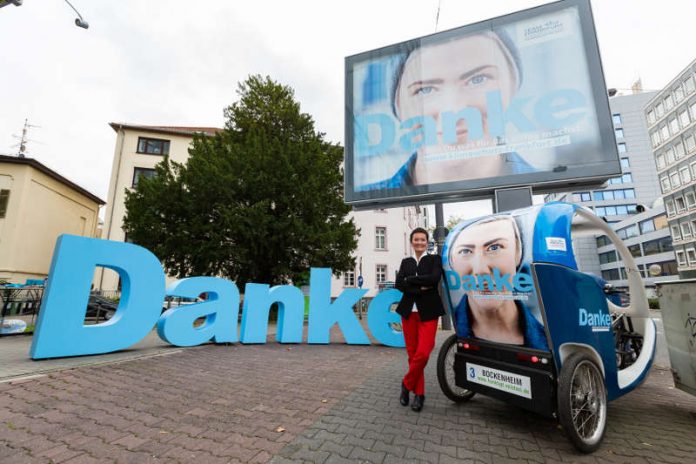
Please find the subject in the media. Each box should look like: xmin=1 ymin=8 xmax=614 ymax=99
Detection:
xmin=396 ymin=227 xmax=445 ymax=412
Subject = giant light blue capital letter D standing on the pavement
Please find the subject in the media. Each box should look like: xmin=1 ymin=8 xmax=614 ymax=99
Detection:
xmin=29 ymin=235 xmax=164 ymax=359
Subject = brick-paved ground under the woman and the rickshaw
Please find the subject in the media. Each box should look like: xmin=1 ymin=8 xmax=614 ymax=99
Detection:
xmin=0 ymin=335 xmax=696 ymax=464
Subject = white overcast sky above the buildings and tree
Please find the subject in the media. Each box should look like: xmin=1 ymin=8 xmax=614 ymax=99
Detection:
xmin=0 ymin=0 xmax=696 ymax=216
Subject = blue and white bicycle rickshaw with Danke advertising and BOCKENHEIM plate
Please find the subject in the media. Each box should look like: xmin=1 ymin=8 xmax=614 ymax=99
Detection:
xmin=437 ymin=203 xmax=656 ymax=453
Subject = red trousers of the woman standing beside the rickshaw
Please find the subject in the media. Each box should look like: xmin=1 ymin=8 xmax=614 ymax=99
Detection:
xmin=401 ymin=312 xmax=437 ymax=395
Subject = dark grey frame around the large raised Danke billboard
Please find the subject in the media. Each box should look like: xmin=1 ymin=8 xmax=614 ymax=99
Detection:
xmin=344 ymin=0 xmax=621 ymax=210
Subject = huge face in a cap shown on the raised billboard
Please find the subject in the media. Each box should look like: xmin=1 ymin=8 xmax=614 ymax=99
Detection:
xmin=395 ymin=35 xmax=517 ymax=153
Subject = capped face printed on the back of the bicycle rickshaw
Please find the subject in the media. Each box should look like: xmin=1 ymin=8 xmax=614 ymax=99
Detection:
xmin=449 ymin=217 xmax=522 ymax=305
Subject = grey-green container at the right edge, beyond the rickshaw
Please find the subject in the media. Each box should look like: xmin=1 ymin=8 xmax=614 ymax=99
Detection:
xmin=655 ymin=279 xmax=696 ymax=395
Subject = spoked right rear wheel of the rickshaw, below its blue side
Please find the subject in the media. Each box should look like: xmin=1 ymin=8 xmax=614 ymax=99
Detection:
xmin=558 ymin=352 xmax=607 ymax=453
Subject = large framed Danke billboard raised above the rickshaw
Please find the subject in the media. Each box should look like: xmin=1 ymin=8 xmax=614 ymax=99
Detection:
xmin=345 ymin=0 xmax=621 ymax=207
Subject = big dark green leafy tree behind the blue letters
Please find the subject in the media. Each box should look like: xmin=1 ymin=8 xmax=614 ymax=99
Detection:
xmin=124 ymin=76 xmax=357 ymax=285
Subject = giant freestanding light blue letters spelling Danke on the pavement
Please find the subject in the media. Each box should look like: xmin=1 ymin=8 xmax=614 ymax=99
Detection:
xmin=29 ymin=235 xmax=404 ymax=359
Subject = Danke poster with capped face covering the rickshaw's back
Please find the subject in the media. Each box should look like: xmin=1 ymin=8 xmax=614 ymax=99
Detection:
xmin=442 ymin=204 xmax=573 ymax=351
